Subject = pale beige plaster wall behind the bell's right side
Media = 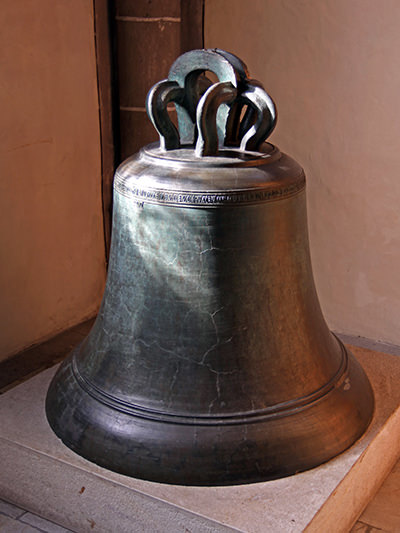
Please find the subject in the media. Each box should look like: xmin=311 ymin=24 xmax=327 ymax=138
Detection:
xmin=205 ymin=0 xmax=400 ymax=344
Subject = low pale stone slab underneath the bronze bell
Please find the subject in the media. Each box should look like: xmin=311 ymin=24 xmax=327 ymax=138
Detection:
xmin=0 ymin=347 xmax=400 ymax=533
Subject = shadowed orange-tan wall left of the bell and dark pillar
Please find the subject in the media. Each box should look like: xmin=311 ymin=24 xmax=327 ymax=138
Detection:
xmin=0 ymin=0 xmax=105 ymax=359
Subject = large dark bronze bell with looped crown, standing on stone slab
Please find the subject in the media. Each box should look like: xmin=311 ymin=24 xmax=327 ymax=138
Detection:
xmin=46 ymin=50 xmax=374 ymax=485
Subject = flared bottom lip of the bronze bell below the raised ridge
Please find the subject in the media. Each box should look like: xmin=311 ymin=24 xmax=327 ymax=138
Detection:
xmin=46 ymin=344 xmax=375 ymax=486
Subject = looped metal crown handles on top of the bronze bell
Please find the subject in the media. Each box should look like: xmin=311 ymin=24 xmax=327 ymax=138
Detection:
xmin=146 ymin=49 xmax=276 ymax=157
